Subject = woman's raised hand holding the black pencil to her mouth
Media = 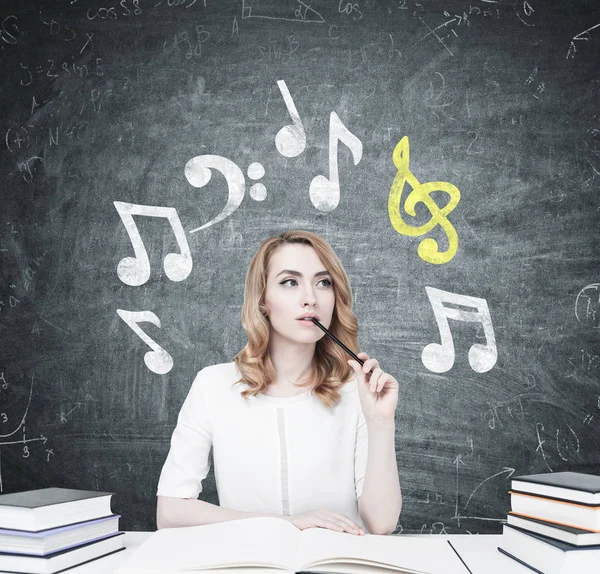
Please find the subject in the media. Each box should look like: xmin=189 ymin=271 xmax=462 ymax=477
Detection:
xmin=348 ymin=353 xmax=399 ymax=421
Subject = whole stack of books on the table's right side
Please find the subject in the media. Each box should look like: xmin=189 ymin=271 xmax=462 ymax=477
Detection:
xmin=498 ymin=472 xmax=600 ymax=574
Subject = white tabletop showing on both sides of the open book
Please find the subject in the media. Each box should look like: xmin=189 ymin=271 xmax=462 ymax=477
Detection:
xmin=56 ymin=532 xmax=531 ymax=574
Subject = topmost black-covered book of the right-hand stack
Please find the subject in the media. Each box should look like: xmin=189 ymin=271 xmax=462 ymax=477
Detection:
xmin=511 ymin=472 xmax=600 ymax=504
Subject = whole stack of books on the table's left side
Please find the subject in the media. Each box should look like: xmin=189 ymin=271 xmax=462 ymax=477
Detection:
xmin=0 ymin=488 xmax=124 ymax=574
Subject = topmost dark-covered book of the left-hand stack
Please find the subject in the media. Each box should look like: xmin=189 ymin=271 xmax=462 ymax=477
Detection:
xmin=0 ymin=488 xmax=113 ymax=532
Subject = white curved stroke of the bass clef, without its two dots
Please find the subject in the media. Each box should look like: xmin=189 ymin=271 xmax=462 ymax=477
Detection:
xmin=184 ymin=155 xmax=246 ymax=233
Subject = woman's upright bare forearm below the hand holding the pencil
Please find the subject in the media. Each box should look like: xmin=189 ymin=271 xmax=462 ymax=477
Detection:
xmin=358 ymin=418 xmax=402 ymax=534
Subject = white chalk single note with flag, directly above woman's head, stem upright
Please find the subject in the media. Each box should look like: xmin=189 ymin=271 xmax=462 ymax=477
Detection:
xmin=309 ymin=112 xmax=362 ymax=212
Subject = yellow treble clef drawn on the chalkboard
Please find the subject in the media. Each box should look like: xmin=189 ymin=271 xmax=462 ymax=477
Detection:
xmin=388 ymin=136 xmax=460 ymax=265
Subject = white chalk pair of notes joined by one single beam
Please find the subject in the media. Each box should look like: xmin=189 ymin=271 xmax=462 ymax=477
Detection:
xmin=113 ymin=201 xmax=192 ymax=287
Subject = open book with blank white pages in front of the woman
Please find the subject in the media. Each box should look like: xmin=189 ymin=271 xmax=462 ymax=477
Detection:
xmin=115 ymin=517 xmax=468 ymax=574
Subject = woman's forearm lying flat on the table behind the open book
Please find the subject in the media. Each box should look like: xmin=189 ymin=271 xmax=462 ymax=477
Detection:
xmin=156 ymin=496 xmax=287 ymax=530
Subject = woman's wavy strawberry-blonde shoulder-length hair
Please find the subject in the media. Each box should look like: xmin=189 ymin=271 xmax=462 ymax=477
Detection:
xmin=233 ymin=231 xmax=358 ymax=408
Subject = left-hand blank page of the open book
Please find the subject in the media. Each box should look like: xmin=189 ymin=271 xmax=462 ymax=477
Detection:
xmin=115 ymin=517 xmax=300 ymax=574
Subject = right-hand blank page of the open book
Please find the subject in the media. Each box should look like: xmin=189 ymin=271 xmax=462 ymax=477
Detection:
xmin=296 ymin=528 xmax=465 ymax=574
